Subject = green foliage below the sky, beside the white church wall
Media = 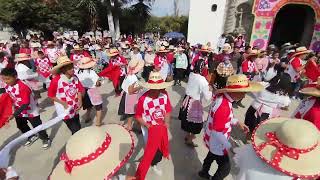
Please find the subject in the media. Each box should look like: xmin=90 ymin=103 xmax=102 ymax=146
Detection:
xmin=145 ymin=16 xmax=188 ymax=35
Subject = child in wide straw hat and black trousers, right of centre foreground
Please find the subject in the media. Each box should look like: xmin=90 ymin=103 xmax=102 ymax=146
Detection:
xmin=199 ymin=74 xmax=263 ymax=180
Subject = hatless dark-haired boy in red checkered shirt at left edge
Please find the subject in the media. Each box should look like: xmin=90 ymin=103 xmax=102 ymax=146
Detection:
xmin=1 ymin=68 xmax=50 ymax=149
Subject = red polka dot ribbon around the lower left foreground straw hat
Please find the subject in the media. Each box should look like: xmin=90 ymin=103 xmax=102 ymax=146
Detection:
xmin=60 ymin=133 xmax=111 ymax=174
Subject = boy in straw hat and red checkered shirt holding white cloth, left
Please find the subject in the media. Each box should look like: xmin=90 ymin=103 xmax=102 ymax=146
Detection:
xmin=48 ymin=56 xmax=84 ymax=134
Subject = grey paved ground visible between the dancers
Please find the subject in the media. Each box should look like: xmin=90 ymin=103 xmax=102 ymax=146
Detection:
xmin=0 ymin=82 xmax=297 ymax=180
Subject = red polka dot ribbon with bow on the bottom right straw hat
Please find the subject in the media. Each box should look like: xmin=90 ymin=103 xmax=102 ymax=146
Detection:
xmin=257 ymin=132 xmax=318 ymax=167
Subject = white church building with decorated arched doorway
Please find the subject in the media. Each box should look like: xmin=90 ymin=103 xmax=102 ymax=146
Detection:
xmin=188 ymin=0 xmax=320 ymax=51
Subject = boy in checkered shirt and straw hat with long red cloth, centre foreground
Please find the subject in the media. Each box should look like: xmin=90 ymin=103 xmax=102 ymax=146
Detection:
xmin=135 ymin=72 xmax=172 ymax=180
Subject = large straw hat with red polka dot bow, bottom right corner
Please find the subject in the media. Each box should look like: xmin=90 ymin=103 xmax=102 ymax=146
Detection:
xmin=252 ymin=118 xmax=320 ymax=179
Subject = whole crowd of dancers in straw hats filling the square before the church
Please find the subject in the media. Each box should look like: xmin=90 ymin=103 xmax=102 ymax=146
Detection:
xmin=0 ymin=32 xmax=320 ymax=180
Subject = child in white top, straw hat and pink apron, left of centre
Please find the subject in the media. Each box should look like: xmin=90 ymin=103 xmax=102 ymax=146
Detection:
xmin=77 ymin=57 xmax=102 ymax=126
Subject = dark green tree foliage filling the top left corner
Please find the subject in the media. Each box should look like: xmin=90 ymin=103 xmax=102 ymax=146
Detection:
xmin=0 ymin=0 xmax=88 ymax=37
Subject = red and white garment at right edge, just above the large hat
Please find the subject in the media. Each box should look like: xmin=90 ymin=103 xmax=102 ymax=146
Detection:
xmin=293 ymin=97 xmax=320 ymax=130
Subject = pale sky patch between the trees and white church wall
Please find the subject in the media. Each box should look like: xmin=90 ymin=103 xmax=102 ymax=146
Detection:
xmin=151 ymin=0 xmax=190 ymax=16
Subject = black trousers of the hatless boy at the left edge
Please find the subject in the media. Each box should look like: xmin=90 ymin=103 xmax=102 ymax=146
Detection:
xmin=15 ymin=116 xmax=49 ymax=140
